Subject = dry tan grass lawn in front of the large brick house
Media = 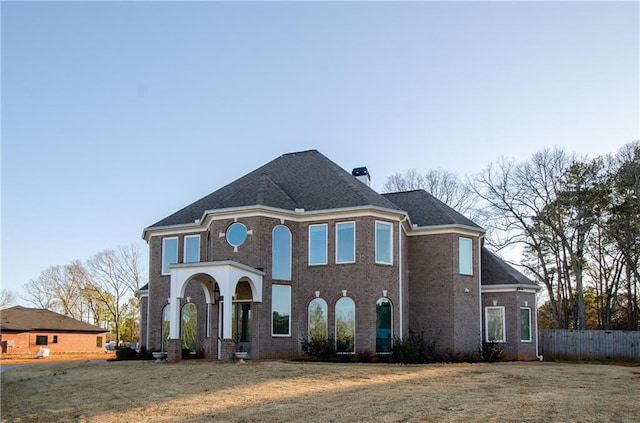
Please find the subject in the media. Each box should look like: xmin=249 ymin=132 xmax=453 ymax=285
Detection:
xmin=2 ymin=360 xmax=640 ymax=423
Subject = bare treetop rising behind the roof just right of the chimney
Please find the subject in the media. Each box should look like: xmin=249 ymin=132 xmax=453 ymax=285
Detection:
xmin=382 ymin=169 xmax=475 ymax=215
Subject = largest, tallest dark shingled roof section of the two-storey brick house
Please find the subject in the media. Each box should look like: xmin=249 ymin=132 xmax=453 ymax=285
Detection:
xmin=149 ymin=150 xmax=398 ymax=228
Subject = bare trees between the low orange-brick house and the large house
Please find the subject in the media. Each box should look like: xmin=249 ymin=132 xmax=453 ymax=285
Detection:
xmin=23 ymin=245 xmax=145 ymax=345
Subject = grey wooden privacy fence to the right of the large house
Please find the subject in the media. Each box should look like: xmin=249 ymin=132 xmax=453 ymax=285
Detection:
xmin=539 ymin=330 xmax=640 ymax=362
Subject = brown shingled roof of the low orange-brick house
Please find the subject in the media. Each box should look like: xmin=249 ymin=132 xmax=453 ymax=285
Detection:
xmin=0 ymin=306 xmax=107 ymax=333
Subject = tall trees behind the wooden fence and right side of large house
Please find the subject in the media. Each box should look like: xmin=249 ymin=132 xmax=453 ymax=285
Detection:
xmin=383 ymin=141 xmax=640 ymax=330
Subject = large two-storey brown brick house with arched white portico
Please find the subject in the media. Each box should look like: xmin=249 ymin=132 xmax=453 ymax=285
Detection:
xmin=137 ymin=150 xmax=539 ymax=360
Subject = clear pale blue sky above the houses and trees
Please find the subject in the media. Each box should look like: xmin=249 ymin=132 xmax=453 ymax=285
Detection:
xmin=1 ymin=2 xmax=640 ymax=303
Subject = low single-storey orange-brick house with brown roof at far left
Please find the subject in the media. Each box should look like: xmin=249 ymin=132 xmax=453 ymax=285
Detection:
xmin=0 ymin=306 xmax=107 ymax=354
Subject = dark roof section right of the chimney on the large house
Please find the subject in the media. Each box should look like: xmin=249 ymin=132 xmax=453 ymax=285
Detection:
xmin=382 ymin=189 xmax=484 ymax=230
